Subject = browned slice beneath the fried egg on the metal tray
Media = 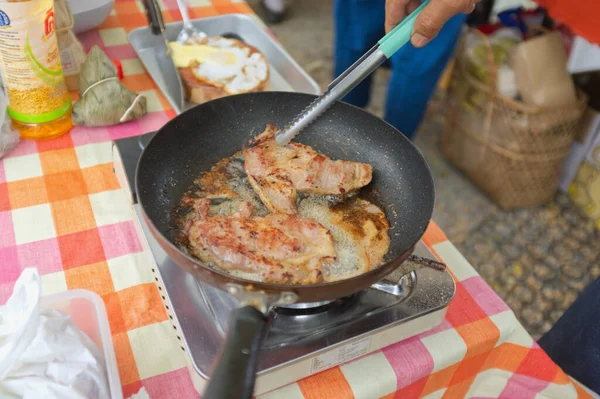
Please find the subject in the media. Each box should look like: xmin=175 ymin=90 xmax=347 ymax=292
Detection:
xmin=179 ymin=37 xmax=270 ymax=104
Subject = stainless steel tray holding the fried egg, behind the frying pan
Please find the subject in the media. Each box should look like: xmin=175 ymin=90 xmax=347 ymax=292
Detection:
xmin=127 ymin=14 xmax=321 ymax=114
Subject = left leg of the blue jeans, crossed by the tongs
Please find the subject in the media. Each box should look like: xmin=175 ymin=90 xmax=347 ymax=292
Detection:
xmin=333 ymin=0 xmax=385 ymax=107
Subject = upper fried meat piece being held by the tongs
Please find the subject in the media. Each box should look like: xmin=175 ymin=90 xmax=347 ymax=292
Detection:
xmin=244 ymin=125 xmax=373 ymax=214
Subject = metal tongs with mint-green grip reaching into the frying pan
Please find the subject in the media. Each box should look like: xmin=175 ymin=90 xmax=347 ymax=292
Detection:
xmin=275 ymin=0 xmax=430 ymax=145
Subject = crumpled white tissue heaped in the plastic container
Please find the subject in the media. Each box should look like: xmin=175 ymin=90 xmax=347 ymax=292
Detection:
xmin=0 ymin=268 xmax=110 ymax=399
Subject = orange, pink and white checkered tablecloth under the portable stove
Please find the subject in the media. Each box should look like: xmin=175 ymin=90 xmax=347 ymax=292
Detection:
xmin=0 ymin=0 xmax=592 ymax=399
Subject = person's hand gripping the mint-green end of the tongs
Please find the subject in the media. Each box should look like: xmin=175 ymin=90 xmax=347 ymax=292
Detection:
xmin=385 ymin=0 xmax=479 ymax=47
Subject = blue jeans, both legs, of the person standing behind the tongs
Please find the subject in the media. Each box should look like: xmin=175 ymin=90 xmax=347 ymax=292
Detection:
xmin=334 ymin=0 xmax=466 ymax=139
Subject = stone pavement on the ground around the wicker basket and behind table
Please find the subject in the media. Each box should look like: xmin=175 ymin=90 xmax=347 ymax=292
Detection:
xmin=250 ymin=0 xmax=600 ymax=338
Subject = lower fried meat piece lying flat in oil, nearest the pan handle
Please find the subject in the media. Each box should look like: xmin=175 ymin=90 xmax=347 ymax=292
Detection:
xmin=184 ymin=198 xmax=336 ymax=284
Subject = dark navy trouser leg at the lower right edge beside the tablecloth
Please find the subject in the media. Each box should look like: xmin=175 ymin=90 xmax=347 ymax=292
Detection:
xmin=538 ymin=278 xmax=600 ymax=394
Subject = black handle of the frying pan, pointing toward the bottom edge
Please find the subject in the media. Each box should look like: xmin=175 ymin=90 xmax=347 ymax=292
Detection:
xmin=202 ymin=306 xmax=267 ymax=399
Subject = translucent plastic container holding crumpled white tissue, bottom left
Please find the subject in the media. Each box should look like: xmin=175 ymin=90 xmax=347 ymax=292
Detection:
xmin=41 ymin=290 xmax=123 ymax=399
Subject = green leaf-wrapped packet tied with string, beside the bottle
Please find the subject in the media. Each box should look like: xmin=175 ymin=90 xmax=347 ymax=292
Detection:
xmin=73 ymin=46 xmax=148 ymax=126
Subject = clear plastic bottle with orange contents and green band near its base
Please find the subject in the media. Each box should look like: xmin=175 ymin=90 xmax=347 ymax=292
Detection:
xmin=0 ymin=0 xmax=73 ymax=139
